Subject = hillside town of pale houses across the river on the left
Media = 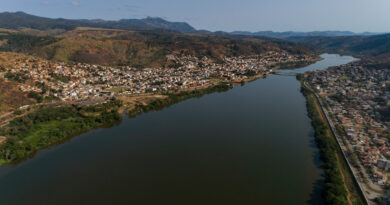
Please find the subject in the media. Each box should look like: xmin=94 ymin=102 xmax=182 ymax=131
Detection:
xmin=0 ymin=51 xmax=313 ymax=101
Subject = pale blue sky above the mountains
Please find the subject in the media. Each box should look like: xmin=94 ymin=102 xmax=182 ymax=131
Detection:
xmin=0 ymin=0 xmax=390 ymax=32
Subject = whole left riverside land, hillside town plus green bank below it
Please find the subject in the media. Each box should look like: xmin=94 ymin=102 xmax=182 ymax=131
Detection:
xmin=0 ymin=51 xmax=319 ymax=167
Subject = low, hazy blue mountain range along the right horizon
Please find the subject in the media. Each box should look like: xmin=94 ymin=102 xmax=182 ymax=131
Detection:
xmin=231 ymin=31 xmax=379 ymax=39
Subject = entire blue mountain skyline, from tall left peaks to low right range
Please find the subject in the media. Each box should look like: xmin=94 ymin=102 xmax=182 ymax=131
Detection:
xmin=0 ymin=11 xmax=382 ymax=39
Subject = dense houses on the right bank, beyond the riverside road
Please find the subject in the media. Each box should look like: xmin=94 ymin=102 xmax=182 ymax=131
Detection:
xmin=308 ymin=62 xmax=390 ymax=184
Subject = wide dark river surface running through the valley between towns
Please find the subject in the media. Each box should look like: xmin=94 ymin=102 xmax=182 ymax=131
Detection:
xmin=0 ymin=54 xmax=354 ymax=205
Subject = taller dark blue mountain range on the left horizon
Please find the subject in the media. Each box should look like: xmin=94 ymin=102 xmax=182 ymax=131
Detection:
xmin=0 ymin=12 xmax=196 ymax=33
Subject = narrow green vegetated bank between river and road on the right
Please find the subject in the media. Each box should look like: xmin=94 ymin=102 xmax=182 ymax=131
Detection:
xmin=297 ymin=74 xmax=366 ymax=205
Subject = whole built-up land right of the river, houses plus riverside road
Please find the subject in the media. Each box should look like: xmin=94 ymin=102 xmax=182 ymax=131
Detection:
xmin=304 ymin=62 xmax=390 ymax=204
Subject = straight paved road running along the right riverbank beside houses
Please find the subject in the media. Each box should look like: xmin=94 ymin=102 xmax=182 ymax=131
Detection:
xmin=304 ymin=82 xmax=376 ymax=205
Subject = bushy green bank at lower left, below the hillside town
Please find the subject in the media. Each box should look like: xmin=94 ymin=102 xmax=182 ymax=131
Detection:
xmin=0 ymin=99 xmax=122 ymax=166
